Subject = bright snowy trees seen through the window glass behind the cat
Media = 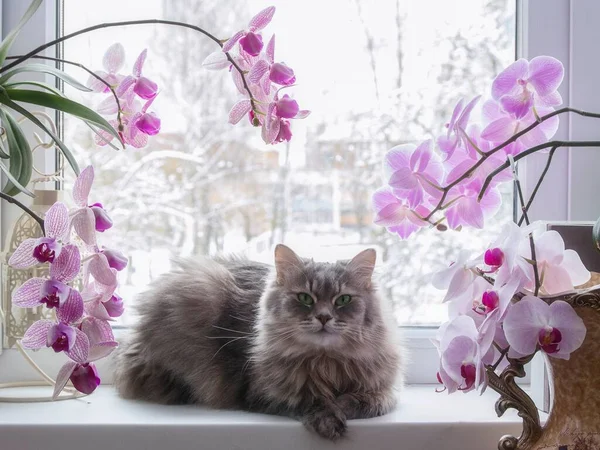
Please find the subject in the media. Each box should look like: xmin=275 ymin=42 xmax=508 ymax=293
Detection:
xmin=63 ymin=0 xmax=515 ymax=325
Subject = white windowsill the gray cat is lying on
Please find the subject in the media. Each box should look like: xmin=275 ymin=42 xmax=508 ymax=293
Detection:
xmin=0 ymin=385 xmax=540 ymax=450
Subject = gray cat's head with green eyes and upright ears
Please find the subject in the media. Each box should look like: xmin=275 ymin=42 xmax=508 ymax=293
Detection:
xmin=263 ymin=246 xmax=379 ymax=350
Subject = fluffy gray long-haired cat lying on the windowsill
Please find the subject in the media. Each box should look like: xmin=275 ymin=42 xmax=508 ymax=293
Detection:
xmin=115 ymin=245 xmax=400 ymax=440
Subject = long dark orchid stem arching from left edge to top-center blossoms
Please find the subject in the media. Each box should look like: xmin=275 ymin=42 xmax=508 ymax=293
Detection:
xmin=0 ymin=19 xmax=255 ymax=110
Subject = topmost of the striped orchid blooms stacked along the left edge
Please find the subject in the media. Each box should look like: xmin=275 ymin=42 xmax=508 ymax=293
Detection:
xmin=8 ymin=202 xmax=69 ymax=269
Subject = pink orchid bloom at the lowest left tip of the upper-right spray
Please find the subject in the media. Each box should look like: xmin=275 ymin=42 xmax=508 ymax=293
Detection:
xmin=373 ymin=187 xmax=428 ymax=239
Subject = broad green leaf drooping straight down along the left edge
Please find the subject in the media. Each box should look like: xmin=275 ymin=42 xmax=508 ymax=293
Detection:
xmin=0 ymin=109 xmax=33 ymax=197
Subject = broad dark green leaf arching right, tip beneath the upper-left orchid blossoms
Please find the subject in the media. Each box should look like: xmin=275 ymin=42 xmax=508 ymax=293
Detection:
xmin=5 ymin=89 xmax=120 ymax=140
